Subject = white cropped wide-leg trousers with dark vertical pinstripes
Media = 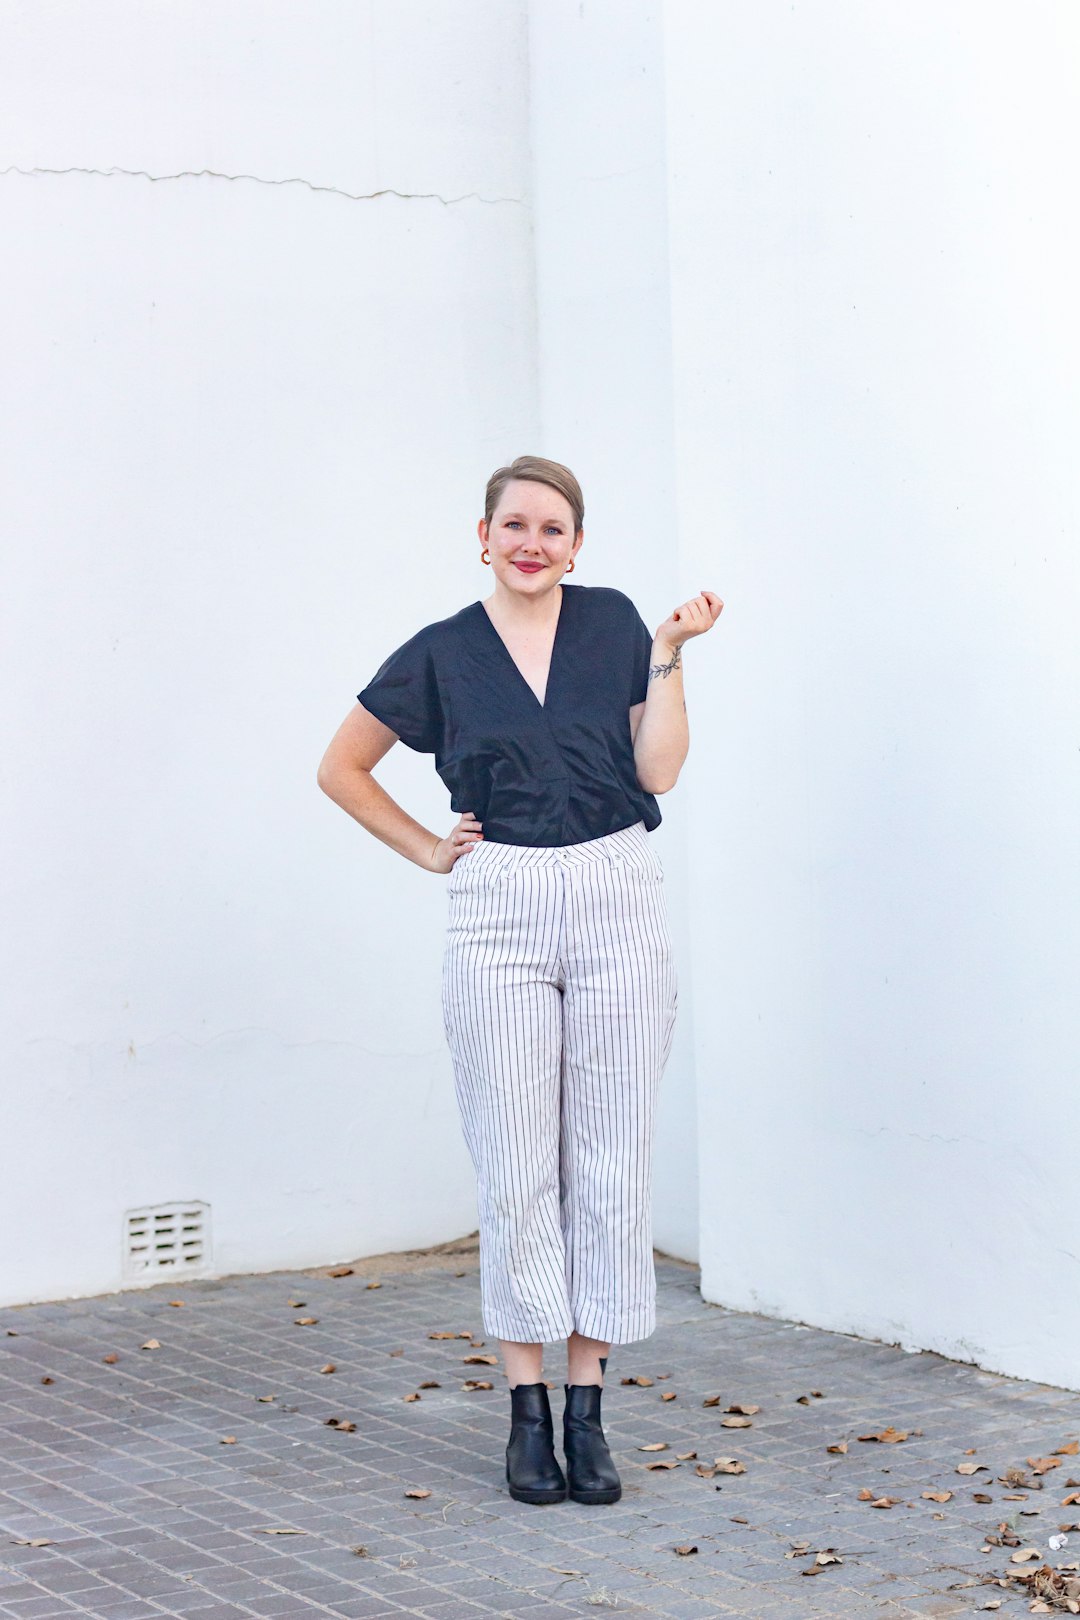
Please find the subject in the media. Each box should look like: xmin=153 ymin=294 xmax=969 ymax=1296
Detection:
xmin=442 ymin=821 xmax=678 ymax=1345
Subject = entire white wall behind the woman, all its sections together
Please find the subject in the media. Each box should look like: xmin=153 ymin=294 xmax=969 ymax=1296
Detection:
xmin=0 ymin=0 xmax=1080 ymax=1385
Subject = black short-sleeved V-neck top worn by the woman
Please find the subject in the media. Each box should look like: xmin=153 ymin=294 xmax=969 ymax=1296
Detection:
xmin=356 ymin=582 xmax=661 ymax=846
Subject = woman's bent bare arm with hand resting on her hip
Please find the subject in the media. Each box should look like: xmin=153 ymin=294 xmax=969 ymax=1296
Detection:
xmin=317 ymin=703 xmax=479 ymax=873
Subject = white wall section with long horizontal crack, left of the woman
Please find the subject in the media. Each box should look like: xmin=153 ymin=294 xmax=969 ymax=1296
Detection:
xmin=0 ymin=0 xmax=538 ymax=1302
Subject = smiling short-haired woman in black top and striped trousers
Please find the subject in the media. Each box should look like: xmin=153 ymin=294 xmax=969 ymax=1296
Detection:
xmin=319 ymin=455 xmax=724 ymax=1502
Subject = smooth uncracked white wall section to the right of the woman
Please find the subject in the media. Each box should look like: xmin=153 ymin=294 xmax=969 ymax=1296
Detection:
xmin=664 ymin=0 xmax=1080 ymax=1387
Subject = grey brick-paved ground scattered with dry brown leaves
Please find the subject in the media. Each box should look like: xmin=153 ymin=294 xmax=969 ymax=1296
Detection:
xmin=0 ymin=1241 xmax=1080 ymax=1620
